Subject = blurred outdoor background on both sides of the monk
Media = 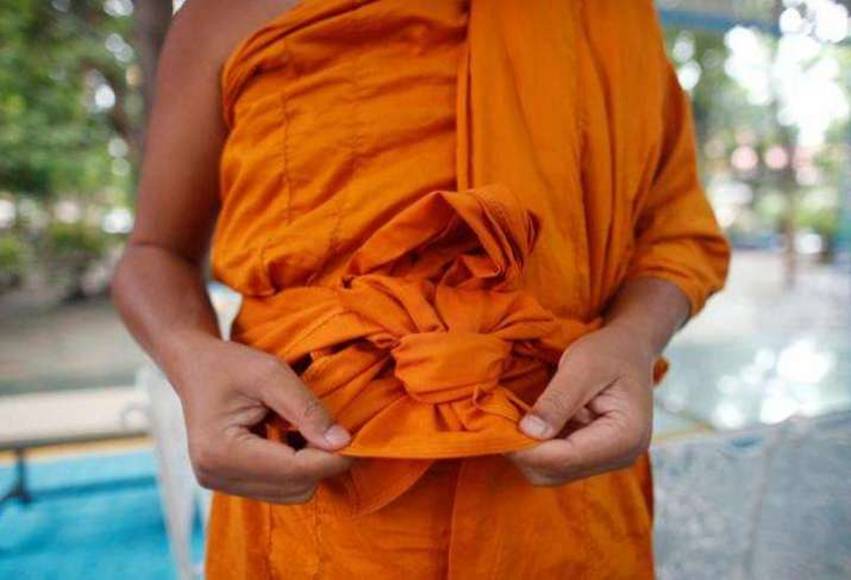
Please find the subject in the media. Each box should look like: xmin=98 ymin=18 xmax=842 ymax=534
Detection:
xmin=0 ymin=0 xmax=851 ymax=579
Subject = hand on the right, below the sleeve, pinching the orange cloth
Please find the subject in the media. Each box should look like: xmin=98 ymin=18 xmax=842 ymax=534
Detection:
xmin=507 ymin=323 xmax=656 ymax=486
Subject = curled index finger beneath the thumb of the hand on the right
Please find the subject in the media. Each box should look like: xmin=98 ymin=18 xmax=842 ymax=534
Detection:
xmin=511 ymin=414 xmax=646 ymax=484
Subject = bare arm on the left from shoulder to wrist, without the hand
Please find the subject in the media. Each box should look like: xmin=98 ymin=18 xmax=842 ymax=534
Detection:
xmin=112 ymin=2 xmax=225 ymax=380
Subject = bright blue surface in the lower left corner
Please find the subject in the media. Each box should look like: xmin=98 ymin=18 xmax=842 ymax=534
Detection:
xmin=0 ymin=450 xmax=203 ymax=580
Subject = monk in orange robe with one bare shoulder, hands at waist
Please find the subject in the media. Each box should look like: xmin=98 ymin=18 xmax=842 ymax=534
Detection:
xmin=113 ymin=0 xmax=730 ymax=580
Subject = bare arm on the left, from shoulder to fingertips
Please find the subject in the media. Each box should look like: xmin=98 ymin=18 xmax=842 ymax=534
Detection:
xmin=112 ymin=0 xmax=351 ymax=503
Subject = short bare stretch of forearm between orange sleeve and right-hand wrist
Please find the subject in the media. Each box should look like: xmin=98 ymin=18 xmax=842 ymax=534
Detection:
xmin=604 ymin=277 xmax=690 ymax=356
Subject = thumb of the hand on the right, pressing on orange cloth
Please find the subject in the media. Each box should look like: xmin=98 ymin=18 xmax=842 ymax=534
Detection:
xmin=519 ymin=358 xmax=611 ymax=439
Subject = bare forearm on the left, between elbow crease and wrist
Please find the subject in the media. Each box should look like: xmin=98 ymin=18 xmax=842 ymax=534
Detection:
xmin=112 ymin=243 xmax=220 ymax=390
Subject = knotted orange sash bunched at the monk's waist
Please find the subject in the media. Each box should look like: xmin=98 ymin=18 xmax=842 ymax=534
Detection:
xmin=236 ymin=185 xmax=600 ymax=459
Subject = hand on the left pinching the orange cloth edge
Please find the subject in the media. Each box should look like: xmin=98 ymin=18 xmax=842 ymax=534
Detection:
xmin=168 ymin=335 xmax=352 ymax=504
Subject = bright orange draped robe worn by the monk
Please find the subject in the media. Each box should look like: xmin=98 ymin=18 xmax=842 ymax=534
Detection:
xmin=206 ymin=0 xmax=729 ymax=580
